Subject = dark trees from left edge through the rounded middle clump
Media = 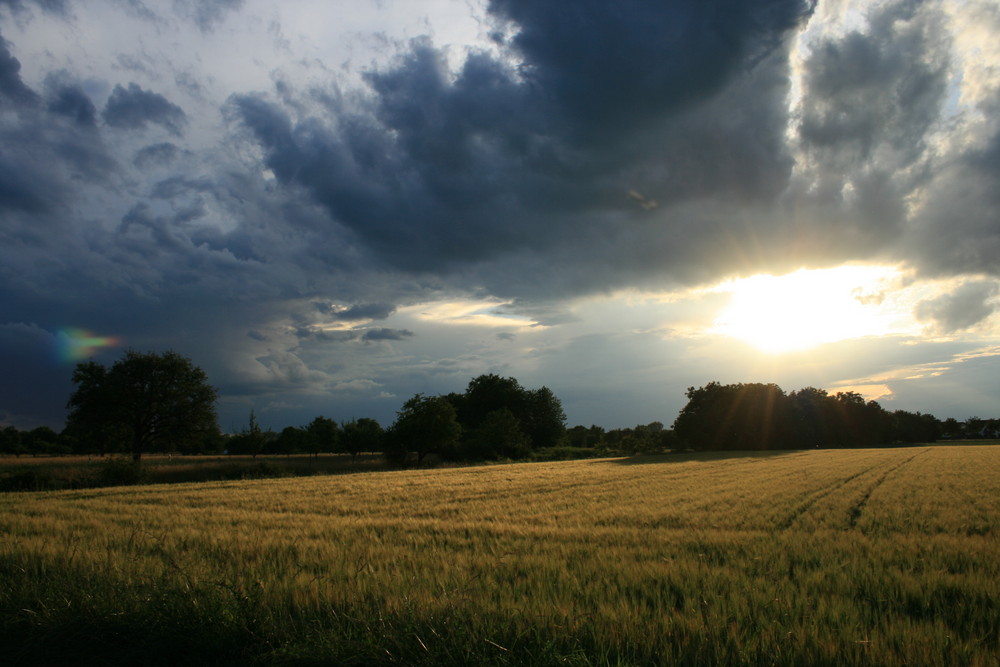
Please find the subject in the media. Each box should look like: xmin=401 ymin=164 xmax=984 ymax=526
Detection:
xmin=0 ymin=350 xmax=566 ymax=464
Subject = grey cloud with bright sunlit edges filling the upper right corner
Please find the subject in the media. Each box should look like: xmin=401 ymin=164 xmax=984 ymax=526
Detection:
xmin=793 ymin=2 xmax=1000 ymax=275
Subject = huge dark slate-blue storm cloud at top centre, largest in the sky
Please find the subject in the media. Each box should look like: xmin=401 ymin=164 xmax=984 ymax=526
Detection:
xmin=230 ymin=1 xmax=811 ymax=293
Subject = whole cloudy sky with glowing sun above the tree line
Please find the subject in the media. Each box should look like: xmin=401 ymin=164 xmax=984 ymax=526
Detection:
xmin=0 ymin=0 xmax=1000 ymax=431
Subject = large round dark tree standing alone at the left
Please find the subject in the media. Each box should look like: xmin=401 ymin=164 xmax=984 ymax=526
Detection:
xmin=67 ymin=350 xmax=219 ymax=462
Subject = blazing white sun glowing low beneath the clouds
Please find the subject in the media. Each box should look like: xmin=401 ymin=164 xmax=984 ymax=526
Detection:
xmin=710 ymin=266 xmax=898 ymax=354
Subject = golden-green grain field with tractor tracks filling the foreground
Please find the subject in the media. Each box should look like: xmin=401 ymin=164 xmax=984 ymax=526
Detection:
xmin=0 ymin=447 xmax=1000 ymax=665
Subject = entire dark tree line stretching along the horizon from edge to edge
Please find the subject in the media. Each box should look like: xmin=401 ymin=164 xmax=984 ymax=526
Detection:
xmin=0 ymin=350 xmax=1000 ymax=465
